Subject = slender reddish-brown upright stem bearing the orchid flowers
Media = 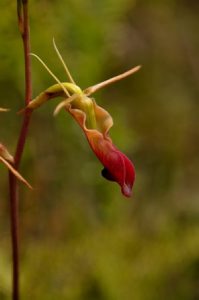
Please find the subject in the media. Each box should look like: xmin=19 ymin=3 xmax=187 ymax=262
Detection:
xmin=9 ymin=0 xmax=32 ymax=300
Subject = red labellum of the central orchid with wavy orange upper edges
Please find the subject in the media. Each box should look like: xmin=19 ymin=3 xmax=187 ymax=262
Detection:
xmin=67 ymin=102 xmax=135 ymax=197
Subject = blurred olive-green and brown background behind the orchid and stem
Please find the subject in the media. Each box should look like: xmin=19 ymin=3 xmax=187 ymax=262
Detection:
xmin=0 ymin=0 xmax=199 ymax=300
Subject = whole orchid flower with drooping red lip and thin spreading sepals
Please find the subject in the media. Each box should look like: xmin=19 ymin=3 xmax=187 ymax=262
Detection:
xmin=25 ymin=41 xmax=140 ymax=197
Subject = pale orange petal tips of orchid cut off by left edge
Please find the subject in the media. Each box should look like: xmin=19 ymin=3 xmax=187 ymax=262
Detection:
xmin=0 ymin=107 xmax=32 ymax=189
